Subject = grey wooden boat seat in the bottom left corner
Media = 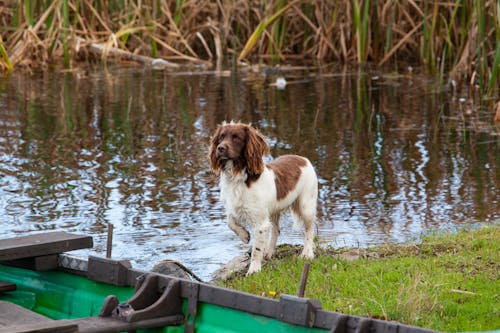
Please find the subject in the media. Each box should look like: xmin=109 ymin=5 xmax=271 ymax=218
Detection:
xmin=0 ymin=301 xmax=78 ymax=333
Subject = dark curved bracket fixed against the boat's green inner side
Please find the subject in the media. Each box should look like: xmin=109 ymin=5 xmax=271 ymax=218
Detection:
xmin=105 ymin=274 xmax=182 ymax=323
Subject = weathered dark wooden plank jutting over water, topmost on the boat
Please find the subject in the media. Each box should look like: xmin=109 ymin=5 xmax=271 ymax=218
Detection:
xmin=0 ymin=231 xmax=93 ymax=261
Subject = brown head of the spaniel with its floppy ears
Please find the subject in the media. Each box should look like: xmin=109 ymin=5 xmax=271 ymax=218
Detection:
xmin=208 ymin=122 xmax=269 ymax=175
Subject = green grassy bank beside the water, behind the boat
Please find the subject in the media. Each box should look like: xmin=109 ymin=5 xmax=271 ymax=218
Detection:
xmin=223 ymin=225 xmax=500 ymax=332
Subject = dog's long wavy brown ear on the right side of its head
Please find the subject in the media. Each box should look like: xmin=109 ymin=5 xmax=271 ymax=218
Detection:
xmin=244 ymin=126 xmax=269 ymax=175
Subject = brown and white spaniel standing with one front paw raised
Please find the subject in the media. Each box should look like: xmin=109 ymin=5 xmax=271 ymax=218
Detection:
xmin=209 ymin=122 xmax=318 ymax=275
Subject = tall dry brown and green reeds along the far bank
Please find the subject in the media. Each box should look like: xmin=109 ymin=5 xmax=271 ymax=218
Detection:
xmin=0 ymin=0 xmax=500 ymax=93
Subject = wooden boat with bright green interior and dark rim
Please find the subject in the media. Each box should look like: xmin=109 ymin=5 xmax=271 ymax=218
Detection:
xmin=0 ymin=232 xmax=438 ymax=333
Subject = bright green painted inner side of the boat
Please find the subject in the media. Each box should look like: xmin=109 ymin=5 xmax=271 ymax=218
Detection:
xmin=0 ymin=265 xmax=328 ymax=333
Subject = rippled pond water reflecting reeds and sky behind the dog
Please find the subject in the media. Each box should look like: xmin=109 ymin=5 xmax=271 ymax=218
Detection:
xmin=0 ymin=67 xmax=500 ymax=280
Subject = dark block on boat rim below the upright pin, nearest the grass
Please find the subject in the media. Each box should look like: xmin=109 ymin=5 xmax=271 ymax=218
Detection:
xmin=279 ymin=295 xmax=321 ymax=327
